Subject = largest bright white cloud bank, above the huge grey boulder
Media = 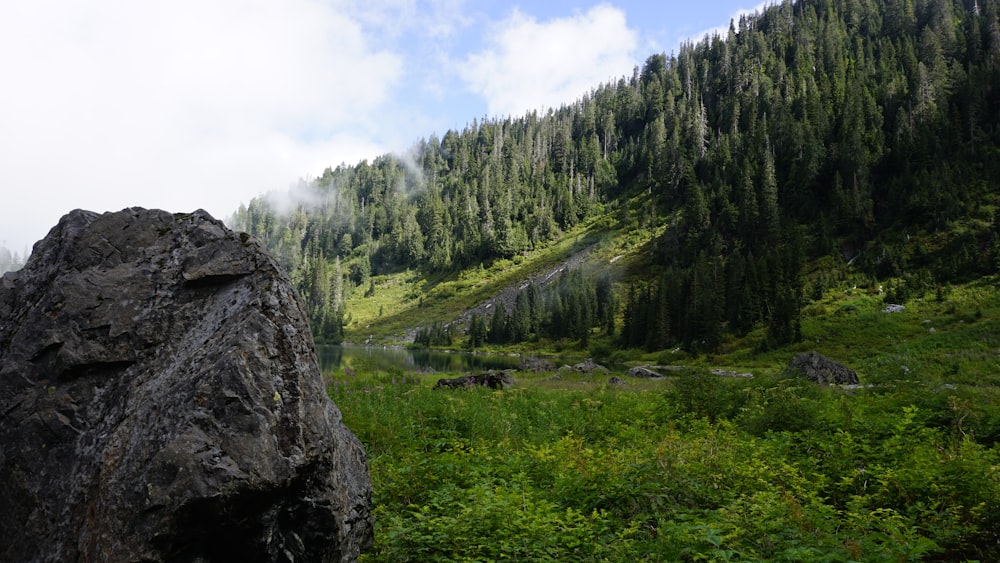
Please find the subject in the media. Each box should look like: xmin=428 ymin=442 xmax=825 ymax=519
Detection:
xmin=0 ymin=0 xmax=403 ymax=249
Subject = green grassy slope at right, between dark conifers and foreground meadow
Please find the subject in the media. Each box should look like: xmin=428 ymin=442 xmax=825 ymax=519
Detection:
xmin=652 ymin=277 xmax=1000 ymax=385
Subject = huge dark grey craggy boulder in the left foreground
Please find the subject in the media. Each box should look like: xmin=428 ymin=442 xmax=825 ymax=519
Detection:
xmin=0 ymin=208 xmax=372 ymax=561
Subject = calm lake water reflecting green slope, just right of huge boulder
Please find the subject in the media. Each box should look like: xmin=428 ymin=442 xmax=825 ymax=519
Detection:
xmin=316 ymin=345 xmax=520 ymax=375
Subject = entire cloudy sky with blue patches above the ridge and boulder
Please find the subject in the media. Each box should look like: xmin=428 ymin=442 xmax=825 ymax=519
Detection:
xmin=0 ymin=0 xmax=764 ymax=254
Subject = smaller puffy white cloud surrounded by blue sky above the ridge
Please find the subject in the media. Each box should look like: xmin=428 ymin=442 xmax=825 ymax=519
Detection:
xmin=460 ymin=5 xmax=638 ymax=119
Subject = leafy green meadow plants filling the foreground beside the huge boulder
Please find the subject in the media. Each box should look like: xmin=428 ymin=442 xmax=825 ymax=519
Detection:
xmin=331 ymin=362 xmax=1000 ymax=561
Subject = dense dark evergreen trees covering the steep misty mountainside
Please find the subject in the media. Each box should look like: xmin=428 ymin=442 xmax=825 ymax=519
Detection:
xmin=232 ymin=0 xmax=1000 ymax=350
